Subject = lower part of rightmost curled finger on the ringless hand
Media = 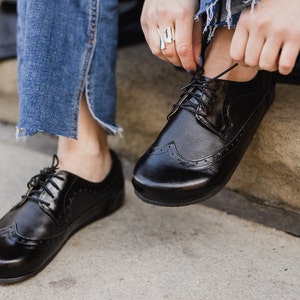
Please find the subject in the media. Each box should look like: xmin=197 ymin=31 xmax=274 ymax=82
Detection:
xmin=278 ymin=43 xmax=299 ymax=75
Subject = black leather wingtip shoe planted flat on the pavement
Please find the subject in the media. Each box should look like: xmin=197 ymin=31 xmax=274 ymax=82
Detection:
xmin=0 ymin=152 xmax=124 ymax=283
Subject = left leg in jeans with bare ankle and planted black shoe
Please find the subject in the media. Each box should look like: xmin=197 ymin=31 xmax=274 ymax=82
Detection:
xmin=0 ymin=0 xmax=124 ymax=283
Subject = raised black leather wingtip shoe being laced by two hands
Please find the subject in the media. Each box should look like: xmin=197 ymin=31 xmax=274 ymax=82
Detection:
xmin=132 ymin=65 xmax=275 ymax=206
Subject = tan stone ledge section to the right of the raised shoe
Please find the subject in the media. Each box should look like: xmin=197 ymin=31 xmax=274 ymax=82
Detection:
xmin=228 ymin=84 xmax=300 ymax=213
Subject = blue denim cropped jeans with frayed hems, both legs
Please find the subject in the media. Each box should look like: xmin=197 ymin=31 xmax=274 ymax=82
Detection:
xmin=17 ymin=0 xmax=257 ymax=138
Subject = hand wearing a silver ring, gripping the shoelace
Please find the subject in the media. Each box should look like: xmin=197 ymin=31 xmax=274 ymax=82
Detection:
xmin=141 ymin=0 xmax=202 ymax=71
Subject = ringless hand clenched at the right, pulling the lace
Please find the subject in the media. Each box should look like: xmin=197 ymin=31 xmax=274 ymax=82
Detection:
xmin=230 ymin=0 xmax=300 ymax=75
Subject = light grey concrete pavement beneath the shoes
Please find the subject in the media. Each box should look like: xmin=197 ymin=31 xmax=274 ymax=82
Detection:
xmin=0 ymin=123 xmax=300 ymax=300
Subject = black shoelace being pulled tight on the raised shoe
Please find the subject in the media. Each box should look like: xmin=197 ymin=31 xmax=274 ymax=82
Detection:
xmin=168 ymin=63 xmax=238 ymax=119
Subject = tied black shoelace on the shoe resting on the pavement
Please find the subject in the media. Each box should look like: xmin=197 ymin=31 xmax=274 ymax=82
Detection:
xmin=17 ymin=155 xmax=64 ymax=207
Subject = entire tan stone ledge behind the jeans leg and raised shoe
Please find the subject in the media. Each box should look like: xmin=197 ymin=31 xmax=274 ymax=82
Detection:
xmin=0 ymin=44 xmax=300 ymax=213
